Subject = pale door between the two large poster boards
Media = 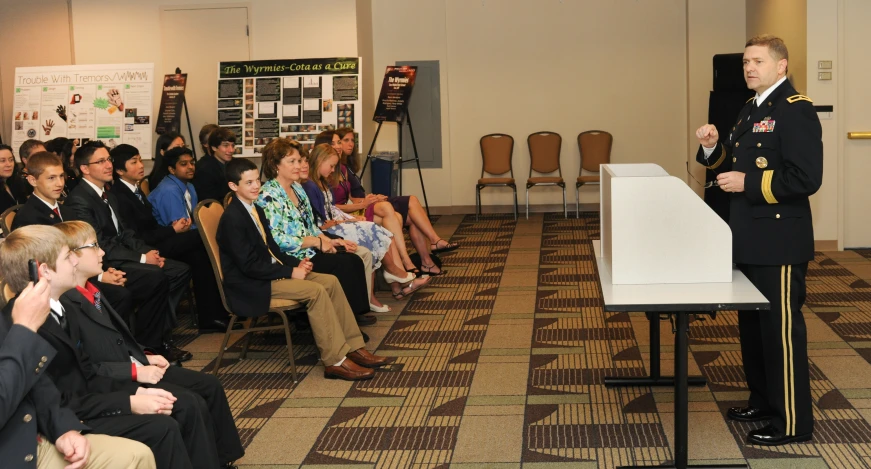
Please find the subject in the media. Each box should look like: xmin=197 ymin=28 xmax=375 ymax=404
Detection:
xmin=156 ymin=5 xmax=250 ymax=156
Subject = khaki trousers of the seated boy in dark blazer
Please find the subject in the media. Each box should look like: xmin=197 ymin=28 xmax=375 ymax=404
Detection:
xmin=272 ymin=272 xmax=366 ymax=366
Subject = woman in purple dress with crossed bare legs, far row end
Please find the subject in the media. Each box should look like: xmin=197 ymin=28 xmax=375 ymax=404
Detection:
xmin=332 ymin=128 xmax=460 ymax=275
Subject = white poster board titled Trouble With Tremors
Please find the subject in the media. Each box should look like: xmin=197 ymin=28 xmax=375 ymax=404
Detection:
xmin=12 ymin=64 xmax=154 ymax=159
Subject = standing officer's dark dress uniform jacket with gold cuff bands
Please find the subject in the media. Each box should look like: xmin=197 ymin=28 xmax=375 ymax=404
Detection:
xmin=696 ymin=80 xmax=823 ymax=265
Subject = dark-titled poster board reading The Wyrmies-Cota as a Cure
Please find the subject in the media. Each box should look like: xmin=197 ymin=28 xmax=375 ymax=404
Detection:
xmin=217 ymin=57 xmax=363 ymax=156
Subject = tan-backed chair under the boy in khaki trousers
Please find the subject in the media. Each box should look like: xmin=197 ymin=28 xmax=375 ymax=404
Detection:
xmin=194 ymin=199 xmax=302 ymax=382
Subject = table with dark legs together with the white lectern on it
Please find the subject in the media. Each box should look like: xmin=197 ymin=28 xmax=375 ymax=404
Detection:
xmin=593 ymin=164 xmax=770 ymax=469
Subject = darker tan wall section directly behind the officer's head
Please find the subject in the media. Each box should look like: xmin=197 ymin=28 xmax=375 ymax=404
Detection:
xmin=746 ymin=0 xmax=809 ymax=93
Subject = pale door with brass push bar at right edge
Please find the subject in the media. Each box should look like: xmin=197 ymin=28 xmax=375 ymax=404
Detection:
xmin=838 ymin=0 xmax=871 ymax=248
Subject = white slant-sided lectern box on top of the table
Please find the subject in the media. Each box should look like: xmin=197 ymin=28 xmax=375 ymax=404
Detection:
xmin=599 ymin=164 xmax=732 ymax=285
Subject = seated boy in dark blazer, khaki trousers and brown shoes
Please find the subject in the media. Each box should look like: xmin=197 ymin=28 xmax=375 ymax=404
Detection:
xmin=217 ymin=158 xmax=395 ymax=380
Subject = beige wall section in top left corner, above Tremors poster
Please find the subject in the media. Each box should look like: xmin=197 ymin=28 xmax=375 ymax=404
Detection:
xmin=0 ymin=0 xmax=73 ymax=150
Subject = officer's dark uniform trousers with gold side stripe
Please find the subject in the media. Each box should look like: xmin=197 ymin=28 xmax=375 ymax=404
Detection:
xmin=738 ymin=263 xmax=813 ymax=435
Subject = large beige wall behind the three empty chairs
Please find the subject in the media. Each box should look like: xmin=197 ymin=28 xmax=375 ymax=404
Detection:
xmin=373 ymin=0 xmax=708 ymax=206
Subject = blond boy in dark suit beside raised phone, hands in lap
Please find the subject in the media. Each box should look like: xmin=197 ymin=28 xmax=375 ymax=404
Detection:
xmin=0 ymin=225 xmax=191 ymax=469
